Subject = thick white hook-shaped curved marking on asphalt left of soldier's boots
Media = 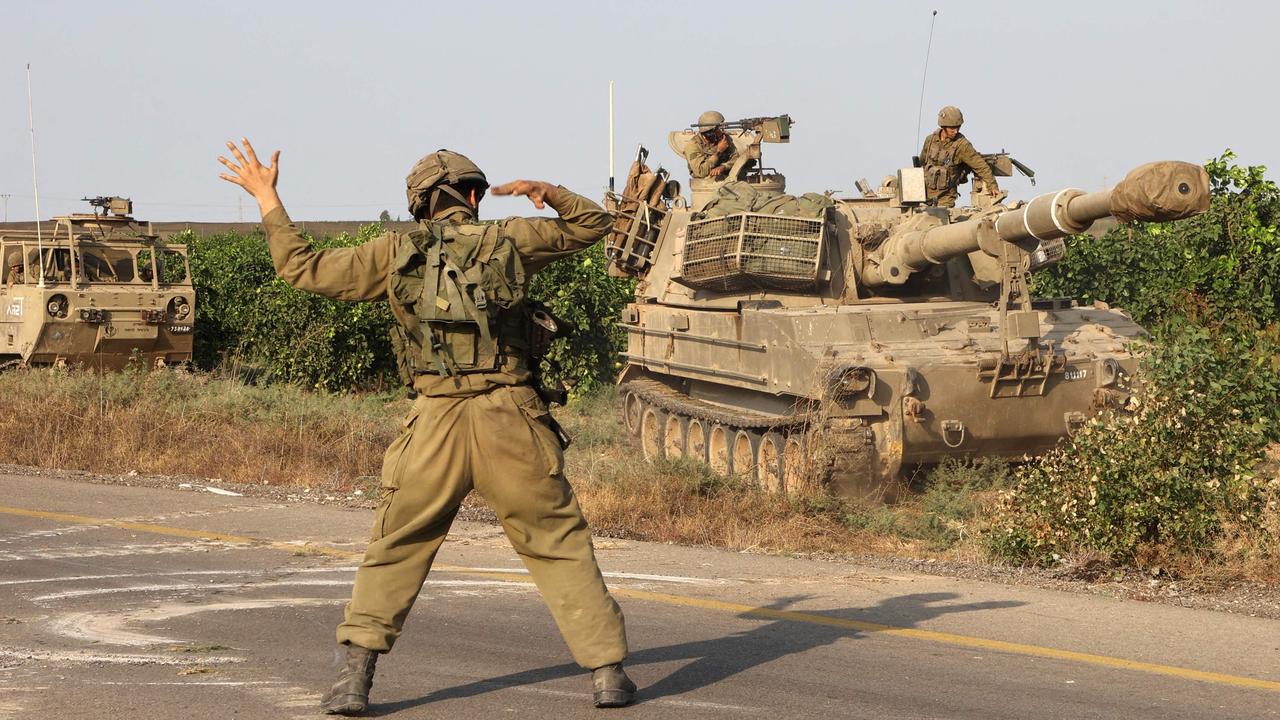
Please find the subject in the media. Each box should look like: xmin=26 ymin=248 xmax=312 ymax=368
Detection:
xmin=47 ymin=597 xmax=346 ymax=646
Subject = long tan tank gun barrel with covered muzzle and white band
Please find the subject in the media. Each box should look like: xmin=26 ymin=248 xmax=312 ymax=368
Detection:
xmin=863 ymin=160 xmax=1210 ymax=287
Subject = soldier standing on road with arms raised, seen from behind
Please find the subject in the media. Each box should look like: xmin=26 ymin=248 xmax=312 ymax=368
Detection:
xmin=219 ymin=138 xmax=636 ymax=715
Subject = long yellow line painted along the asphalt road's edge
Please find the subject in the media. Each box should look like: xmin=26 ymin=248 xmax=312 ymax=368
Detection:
xmin=0 ymin=505 xmax=1280 ymax=692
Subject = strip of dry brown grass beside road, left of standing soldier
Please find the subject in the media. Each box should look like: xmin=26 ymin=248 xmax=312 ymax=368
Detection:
xmin=0 ymin=369 xmax=407 ymax=491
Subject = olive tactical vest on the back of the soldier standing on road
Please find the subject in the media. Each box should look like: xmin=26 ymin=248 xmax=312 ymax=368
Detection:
xmin=389 ymin=222 xmax=529 ymax=386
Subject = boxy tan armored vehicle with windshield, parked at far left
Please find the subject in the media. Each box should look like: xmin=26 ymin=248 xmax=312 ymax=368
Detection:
xmin=0 ymin=197 xmax=196 ymax=369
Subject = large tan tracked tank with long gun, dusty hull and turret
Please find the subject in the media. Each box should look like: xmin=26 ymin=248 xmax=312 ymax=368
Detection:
xmin=607 ymin=118 xmax=1210 ymax=501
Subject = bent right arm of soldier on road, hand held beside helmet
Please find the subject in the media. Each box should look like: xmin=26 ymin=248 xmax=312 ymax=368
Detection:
xmin=490 ymin=181 xmax=613 ymax=273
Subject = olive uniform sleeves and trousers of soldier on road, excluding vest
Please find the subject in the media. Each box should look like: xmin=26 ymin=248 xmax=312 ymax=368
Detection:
xmin=264 ymin=187 xmax=627 ymax=669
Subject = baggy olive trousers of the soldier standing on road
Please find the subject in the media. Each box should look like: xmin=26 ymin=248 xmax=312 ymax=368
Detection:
xmin=338 ymin=386 xmax=627 ymax=669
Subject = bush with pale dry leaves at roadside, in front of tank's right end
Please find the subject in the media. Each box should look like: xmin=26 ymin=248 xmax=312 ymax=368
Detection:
xmin=988 ymin=325 xmax=1280 ymax=565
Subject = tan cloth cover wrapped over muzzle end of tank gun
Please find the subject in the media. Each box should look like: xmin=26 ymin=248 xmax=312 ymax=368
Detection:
xmin=1111 ymin=160 xmax=1210 ymax=223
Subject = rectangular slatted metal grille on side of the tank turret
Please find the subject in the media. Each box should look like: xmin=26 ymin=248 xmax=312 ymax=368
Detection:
xmin=680 ymin=213 xmax=827 ymax=292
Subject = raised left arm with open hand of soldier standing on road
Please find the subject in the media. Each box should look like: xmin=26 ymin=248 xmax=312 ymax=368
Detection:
xmin=218 ymin=137 xmax=396 ymax=301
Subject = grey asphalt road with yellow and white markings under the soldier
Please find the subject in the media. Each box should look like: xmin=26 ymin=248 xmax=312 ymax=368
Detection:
xmin=0 ymin=477 xmax=1280 ymax=720
